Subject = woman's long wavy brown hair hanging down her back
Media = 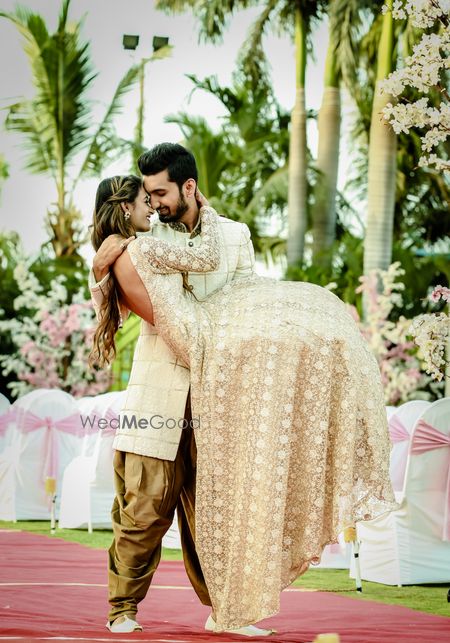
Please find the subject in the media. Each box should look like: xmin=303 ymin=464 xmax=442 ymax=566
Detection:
xmin=89 ymin=174 xmax=142 ymax=366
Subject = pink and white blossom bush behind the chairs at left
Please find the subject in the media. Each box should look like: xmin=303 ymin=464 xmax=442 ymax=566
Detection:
xmin=0 ymin=239 xmax=110 ymax=397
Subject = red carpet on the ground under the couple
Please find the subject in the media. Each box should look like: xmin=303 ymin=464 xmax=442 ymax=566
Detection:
xmin=0 ymin=530 xmax=450 ymax=643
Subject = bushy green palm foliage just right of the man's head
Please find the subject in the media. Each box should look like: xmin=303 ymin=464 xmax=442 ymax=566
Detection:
xmin=166 ymin=68 xmax=289 ymax=249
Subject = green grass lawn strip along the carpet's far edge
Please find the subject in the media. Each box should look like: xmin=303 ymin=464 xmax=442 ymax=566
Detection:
xmin=0 ymin=521 xmax=450 ymax=616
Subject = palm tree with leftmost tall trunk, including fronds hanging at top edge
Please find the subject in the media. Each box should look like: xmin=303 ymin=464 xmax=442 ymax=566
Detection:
xmin=156 ymin=0 xmax=326 ymax=264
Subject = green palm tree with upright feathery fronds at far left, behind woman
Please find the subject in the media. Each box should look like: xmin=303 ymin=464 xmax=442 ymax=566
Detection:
xmin=0 ymin=0 xmax=139 ymax=257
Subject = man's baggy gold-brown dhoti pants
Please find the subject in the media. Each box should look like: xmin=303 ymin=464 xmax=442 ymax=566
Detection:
xmin=108 ymin=400 xmax=211 ymax=621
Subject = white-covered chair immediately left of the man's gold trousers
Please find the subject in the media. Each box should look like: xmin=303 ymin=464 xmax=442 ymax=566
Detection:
xmin=58 ymin=391 xmax=126 ymax=532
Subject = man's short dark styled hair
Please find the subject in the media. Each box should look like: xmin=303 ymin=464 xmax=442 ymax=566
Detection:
xmin=138 ymin=143 xmax=198 ymax=190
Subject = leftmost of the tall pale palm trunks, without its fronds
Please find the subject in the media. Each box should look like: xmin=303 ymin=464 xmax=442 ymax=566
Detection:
xmin=287 ymin=9 xmax=308 ymax=265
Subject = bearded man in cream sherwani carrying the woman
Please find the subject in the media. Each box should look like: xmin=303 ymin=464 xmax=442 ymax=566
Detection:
xmin=90 ymin=143 xmax=270 ymax=636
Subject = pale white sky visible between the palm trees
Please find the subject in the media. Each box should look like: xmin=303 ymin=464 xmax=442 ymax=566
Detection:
xmin=0 ymin=0 xmax=352 ymax=261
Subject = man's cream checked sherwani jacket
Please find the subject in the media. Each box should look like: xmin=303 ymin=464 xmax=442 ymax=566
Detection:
xmin=90 ymin=217 xmax=255 ymax=460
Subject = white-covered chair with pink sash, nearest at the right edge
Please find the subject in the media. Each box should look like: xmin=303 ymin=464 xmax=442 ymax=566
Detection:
xmin=351 ymin=398 xmax=450 ymax=585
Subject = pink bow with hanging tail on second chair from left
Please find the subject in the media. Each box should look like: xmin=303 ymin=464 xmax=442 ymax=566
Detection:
xmin=19 ymin=411 xmax=82 ymax=478
